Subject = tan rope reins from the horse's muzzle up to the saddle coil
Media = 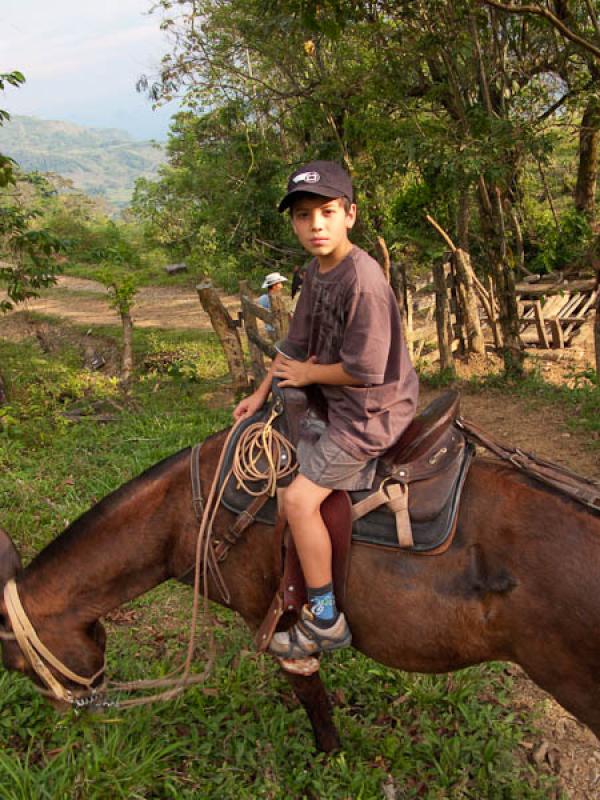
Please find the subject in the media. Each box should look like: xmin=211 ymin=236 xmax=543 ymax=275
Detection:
xmin=0 ymin=404 xmax=296 ymax=709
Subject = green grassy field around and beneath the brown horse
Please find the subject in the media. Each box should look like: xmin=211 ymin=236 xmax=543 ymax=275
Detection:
xmin=0 ymin=316 xmax=576 ymax=800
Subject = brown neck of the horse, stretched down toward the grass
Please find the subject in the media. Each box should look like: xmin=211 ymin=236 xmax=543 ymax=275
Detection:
xmin=19 ymin=451 xmax=193 ymax=624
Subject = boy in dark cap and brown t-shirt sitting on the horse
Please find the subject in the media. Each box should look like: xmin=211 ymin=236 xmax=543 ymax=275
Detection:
xmin=233 ymin=161 xmax=418 ymax=659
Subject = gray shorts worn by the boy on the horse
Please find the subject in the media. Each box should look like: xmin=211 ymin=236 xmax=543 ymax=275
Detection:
xmin=296 ymin=430 xmax=377 ymax=492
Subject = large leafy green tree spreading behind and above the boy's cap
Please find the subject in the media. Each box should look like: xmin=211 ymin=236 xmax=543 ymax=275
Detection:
xmin=138 ymin=0 xmax=594 ymax=375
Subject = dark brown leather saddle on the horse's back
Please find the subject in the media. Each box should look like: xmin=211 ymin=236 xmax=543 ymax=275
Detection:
xmin=221 ymin=386 xmax=474 ymax=554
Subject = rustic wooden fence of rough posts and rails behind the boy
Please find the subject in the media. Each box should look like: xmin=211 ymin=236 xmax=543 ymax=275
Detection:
xmin=196 ymin=264 xmax=600 ymax=393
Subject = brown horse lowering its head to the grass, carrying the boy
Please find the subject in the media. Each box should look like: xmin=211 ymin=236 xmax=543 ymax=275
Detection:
xmin=0 ymin=433 xmax=600 ymax=751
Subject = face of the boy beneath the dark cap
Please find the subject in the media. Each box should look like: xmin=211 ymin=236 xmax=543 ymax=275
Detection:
xmin=291 ymin=195 xmax=356 ymax=266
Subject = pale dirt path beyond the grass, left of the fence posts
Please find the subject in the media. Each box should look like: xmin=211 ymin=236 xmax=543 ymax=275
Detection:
xmin=5 ymin=275 xmax=239 ymax=330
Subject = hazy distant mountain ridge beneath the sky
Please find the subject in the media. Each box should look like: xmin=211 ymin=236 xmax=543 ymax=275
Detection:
xmin=0 ymin=116 xmax=165 ymax=208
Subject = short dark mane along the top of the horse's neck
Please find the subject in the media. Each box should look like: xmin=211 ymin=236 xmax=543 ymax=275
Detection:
xmin=27 ymin=447 xmax=190 ymax=569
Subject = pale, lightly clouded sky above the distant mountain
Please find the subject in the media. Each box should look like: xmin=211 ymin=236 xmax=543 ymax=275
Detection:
xmin=0 ymin=0 xmax=177 ymax=141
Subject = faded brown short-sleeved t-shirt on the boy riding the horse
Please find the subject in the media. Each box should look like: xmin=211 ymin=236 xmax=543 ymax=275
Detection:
xmin=279 ymin=247 xmax=419 ymax=461
